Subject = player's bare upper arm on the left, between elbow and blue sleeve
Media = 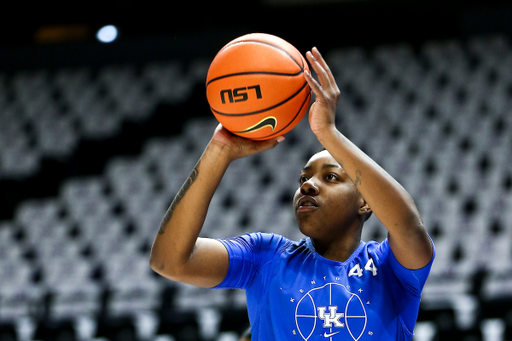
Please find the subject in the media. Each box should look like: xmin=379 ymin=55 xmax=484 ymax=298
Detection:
xmin=152 ymin=238 xmax=229 ymax=288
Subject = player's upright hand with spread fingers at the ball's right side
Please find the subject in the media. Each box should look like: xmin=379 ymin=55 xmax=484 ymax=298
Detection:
xmin=305 ymin=47 xmax=340 ymax=136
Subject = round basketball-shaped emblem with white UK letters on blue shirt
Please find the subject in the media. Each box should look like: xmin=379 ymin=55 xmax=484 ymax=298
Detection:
xmin=295 ymin=283 xmax=368 ymax=341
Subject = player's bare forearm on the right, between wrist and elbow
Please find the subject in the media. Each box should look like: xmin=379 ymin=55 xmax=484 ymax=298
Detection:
xmin=318 ymin=128 xmax=421 ymax=233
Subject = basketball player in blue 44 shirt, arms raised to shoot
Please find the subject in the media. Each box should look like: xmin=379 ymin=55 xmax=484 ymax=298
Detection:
xmin=150 ymin=48 xmax=434 ymax=341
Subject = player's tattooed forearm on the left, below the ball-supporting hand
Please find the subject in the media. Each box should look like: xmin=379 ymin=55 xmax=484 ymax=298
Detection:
xmin=150 ymin=144 xmax=230 ymax=272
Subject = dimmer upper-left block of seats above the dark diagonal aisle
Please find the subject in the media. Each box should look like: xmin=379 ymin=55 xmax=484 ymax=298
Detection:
xmin=0 ymin=60 xmax=210 ymax=179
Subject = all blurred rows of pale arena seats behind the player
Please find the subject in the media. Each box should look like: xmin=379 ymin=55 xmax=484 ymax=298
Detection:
xmin=0 ymin=36 xmax=512 ymax=341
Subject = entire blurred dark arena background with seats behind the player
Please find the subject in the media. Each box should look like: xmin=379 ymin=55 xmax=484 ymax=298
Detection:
xmin=0 ymin=0 xmax=512 ymax=341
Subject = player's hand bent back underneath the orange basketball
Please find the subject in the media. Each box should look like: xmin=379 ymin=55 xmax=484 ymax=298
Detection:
xmin=210 ymin=123 xmax=284 ymax=161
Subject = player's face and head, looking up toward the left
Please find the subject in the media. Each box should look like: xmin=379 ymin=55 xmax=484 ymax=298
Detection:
xmin=293 ymin=151 xmax=364 ymax=241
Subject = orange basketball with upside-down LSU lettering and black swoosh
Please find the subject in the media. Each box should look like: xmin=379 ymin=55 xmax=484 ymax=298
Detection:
xmin=206 ymin=33 xmax=311 ymax=140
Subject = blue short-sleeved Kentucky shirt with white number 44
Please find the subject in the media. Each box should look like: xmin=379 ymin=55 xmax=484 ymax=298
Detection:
xmin=216 ymin=233 xmax=434 ymax=341
